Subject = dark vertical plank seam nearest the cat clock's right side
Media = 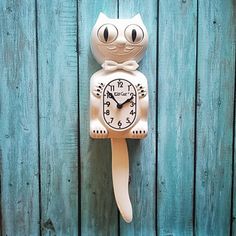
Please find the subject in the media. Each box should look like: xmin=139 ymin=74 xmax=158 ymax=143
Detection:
xmin=155 ymin=0 xmax=160 ymax=236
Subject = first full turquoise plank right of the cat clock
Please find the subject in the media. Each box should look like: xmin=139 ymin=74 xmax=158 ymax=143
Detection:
xmin=157 ymin=0 xmax=197 ymax=236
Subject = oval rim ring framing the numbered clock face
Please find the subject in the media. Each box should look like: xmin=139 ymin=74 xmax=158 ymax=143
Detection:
xmin=102 ymin=78 xmax=138 ymax=132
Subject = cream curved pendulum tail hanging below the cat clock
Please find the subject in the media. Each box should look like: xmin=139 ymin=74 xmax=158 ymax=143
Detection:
xmin=111 ymin=138 xmax=133 ymax=223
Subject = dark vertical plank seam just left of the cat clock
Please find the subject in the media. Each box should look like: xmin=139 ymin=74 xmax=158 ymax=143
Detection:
xmin=76 ymin=0 xmax=82 ymax=235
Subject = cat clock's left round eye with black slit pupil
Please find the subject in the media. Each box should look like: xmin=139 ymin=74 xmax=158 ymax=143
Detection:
xmin=98 ymin=24 xmax=118 ymax=43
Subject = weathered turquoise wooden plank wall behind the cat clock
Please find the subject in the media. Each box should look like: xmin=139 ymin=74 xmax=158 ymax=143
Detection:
xmin=0 ymin=0 xmax=236 ymax=236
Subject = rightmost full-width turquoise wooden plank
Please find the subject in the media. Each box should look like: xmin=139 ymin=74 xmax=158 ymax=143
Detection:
xmin=195 ymin=0 xmax=235 ymax=235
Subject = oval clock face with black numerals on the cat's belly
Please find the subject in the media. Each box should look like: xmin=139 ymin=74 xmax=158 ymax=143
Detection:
xmin=103 ymin=79 xmax=137 ymax=130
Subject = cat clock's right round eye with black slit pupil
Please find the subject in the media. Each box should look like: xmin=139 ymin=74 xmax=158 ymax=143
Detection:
xmin=125 ymin=25 xmax=144 ymax=43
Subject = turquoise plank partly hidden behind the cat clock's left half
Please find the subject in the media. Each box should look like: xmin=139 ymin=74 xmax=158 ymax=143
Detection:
xmin=78 ymin=0 xmax=118 ymax=236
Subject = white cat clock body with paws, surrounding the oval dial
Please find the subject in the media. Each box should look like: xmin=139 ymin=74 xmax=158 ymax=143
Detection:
xmin=90 ymin=69 xmax=148 ymax=139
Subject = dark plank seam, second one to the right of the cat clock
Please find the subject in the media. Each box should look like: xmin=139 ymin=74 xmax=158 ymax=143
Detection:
xmin=192 ymin=0 xmax=199 ymax=236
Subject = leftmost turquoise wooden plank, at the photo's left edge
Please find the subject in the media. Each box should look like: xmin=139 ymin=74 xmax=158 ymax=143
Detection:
xmin=0 ymin=0 xmax=39 ymax=235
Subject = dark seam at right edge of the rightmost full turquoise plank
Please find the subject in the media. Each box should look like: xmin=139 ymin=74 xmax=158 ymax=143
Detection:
xmin=230 ymin=50 xmax=236 ymax=236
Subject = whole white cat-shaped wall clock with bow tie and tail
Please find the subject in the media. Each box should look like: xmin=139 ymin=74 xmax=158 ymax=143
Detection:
xmin=90 ymin=13 xmax=148 ymax=223
